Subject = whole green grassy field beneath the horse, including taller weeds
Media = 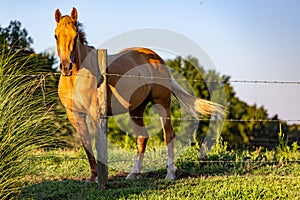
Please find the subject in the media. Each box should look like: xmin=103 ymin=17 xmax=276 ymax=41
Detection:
xmin=19 ymin=139 xmax=300 ymax=200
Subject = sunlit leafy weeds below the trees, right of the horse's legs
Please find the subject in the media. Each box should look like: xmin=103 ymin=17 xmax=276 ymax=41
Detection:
xmin=176 ymin=133 xmax=300 ymax=178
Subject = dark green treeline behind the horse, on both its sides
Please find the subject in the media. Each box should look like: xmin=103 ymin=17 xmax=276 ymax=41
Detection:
xmin=0 ymin=21 xmax=300 ymax=148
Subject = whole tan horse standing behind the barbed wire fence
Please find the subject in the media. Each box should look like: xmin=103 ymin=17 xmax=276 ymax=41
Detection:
xmin=55 ymin=7 xmax=224 ymax=182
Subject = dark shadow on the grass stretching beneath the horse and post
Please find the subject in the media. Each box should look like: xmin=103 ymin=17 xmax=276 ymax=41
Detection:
xmin=19 ymin=162 xmax=243 ymax=200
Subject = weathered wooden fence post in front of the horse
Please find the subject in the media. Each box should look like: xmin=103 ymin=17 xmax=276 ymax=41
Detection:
xmin=96 ymin=49 xmax=108 ymax=189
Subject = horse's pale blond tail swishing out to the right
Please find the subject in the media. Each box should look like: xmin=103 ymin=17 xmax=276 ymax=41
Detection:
xmin=172 ymin=79 xmax=225 ymax=119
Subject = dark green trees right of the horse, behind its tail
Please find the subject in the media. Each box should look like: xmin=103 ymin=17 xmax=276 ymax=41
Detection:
xmin=167 ymin=56 xmax=299 ymax=147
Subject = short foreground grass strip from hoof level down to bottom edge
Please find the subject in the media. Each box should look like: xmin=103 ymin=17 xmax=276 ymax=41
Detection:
xmin=21 ymin=175 xmax=300 ymax=199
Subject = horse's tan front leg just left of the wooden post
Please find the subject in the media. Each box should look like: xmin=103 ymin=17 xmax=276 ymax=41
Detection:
xmin=67 ymin=110 xmax=97 ymax=182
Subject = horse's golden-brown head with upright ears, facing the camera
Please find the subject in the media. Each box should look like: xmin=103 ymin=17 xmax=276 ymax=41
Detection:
xmin=55 ymin=8 xmax=78 ymax=76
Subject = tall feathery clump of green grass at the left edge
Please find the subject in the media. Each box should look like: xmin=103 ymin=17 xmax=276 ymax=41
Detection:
xmin=0 ymin=44 xmax=58 ymax=199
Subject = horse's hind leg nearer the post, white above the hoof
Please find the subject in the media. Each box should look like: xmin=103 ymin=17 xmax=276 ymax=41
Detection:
xmin=126 ymin=105 xmax=149 ymax=179
